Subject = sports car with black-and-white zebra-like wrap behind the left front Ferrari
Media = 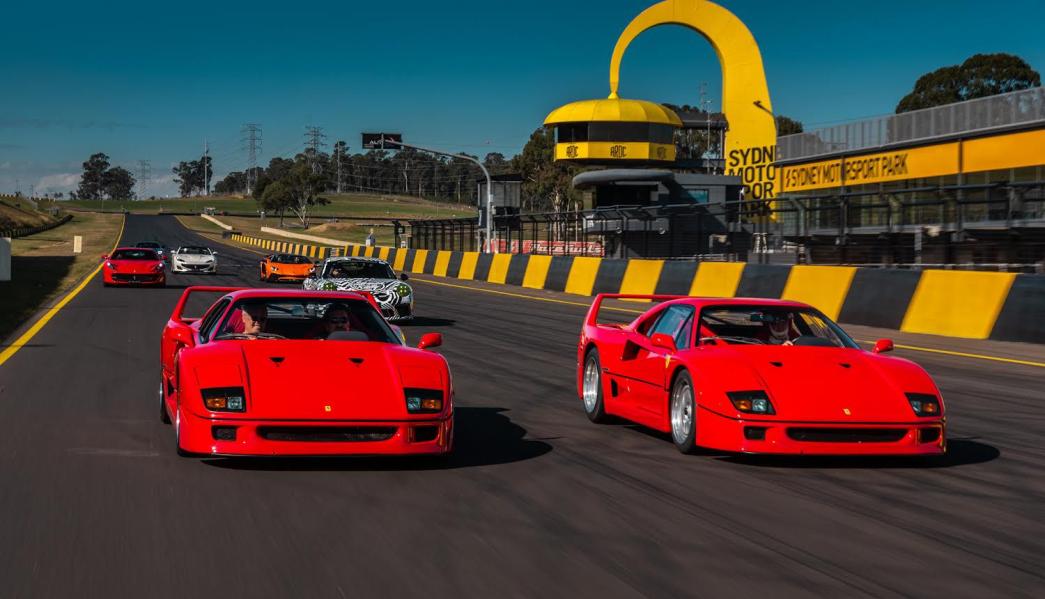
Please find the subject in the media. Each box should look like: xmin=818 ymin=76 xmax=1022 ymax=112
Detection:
xmin=303 ymin=257 xmax=414 ymax=320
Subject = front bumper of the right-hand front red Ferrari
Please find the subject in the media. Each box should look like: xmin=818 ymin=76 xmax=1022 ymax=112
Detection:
xmin=696 ymin=406 xmax=947 ymax=456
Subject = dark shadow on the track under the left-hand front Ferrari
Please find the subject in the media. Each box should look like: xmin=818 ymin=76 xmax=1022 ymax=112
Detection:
xmin=203 ymin=408 xmax=552 ymax=471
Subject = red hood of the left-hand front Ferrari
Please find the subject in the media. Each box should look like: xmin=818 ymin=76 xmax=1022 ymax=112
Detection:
xmin=187 ymin=340 xmax=445 ymax=420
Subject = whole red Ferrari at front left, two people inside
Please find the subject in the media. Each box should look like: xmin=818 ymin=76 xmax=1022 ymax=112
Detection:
xmin=159 ymin=286 xmax=454 ymax=456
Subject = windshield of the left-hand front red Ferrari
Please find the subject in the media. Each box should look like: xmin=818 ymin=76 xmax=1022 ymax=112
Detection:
xmin=214 ymin=298 xmax=401 ymax=345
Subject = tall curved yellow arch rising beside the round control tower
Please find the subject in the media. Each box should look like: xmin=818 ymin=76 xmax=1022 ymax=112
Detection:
xmin=609 ymin=0 xmax=777 ymax=200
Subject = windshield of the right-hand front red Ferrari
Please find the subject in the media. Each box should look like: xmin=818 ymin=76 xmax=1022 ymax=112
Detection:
xmin=700 ymin=305 xmax=858 ymax=348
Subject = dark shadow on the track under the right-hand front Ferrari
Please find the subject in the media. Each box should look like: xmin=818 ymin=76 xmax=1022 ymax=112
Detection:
xmin=718 ymin=439 xmax=1001 ymax=469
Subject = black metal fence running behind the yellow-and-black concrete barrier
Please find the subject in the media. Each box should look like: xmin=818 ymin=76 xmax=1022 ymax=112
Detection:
xmin=405 ymin=182 xmax=1045 ymax=271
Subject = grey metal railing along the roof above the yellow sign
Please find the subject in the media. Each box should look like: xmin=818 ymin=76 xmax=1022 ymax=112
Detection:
xmin=776 ymin=87 xmax=1045 ymax=161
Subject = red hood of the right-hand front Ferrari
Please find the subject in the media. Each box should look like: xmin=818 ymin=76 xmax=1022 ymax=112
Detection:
xmin=709 ymin=346 xmax=937 ymax=422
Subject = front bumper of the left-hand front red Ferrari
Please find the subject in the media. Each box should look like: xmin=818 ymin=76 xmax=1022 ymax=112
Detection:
xmin=181 ymin=412 xmax=454 ymax=456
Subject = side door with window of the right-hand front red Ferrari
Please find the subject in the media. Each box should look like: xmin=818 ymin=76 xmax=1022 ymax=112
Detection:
xmin=633 ymin=304 xmax=696 ymax=416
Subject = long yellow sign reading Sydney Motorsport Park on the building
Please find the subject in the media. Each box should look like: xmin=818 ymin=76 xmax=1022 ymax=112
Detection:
xmin=781 ymin=142 xmax=960 ymax=192
